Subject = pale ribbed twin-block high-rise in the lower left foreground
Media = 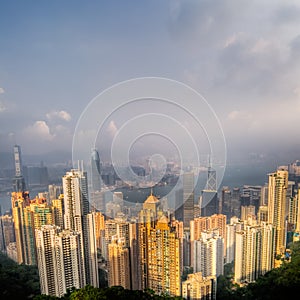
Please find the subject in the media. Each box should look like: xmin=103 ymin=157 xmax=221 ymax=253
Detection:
xmin=36 ymin=225 xmax=85 ymax=297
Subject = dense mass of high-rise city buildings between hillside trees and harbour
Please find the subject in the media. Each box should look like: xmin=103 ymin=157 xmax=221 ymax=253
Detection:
xmin=0 ymin=146 xmax=300 ymax=299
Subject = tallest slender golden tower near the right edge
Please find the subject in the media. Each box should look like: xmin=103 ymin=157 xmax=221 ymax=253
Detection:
xmin=268 ymin=170 xmax=288 ymax=255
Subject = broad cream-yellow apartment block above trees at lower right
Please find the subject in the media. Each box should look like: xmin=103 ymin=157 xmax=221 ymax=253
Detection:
xmin=234 ymin=222 xmax=275 ymax=284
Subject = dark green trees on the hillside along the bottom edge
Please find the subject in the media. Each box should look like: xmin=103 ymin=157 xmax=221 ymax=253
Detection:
xmin=0 ymin=242 xmax=300 ymax=300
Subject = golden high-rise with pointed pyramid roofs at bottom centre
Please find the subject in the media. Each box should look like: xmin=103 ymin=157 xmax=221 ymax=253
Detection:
xmin=138 ymin=194 xmax=182 ymax=296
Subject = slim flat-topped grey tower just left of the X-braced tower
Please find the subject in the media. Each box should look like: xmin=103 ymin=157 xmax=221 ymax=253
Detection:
xmin=182 ymin=172 xmax=195 ymax=230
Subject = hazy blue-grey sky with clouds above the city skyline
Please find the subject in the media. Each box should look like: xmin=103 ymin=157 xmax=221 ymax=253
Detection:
xmin=0 ymin=0 xmax=300 ymax=169
